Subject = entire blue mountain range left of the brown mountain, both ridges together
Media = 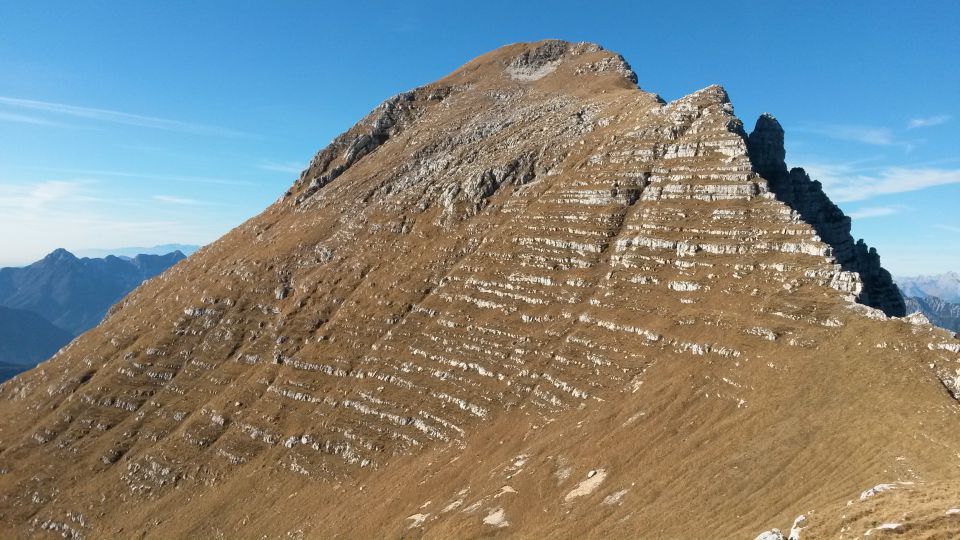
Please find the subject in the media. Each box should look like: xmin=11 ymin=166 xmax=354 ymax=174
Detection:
xmin=0 ymin=249 xmax=185 ymax=381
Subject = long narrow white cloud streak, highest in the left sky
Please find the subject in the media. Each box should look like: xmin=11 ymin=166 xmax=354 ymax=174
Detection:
xmin=0 ymin=96 xmax=247 ymax=137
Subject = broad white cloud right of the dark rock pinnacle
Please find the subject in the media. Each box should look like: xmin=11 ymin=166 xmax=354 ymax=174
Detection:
xmin=804 ymin=163 xmax=960 ymax=202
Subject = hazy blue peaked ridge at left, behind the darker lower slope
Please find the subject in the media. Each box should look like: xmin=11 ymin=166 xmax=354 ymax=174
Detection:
xmin=0 ymin=249 xmax=184 ymax=336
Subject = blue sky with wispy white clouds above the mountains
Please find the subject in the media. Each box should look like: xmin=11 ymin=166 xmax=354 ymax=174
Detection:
xmin=0 ymin=0 xmax=960 ymax=274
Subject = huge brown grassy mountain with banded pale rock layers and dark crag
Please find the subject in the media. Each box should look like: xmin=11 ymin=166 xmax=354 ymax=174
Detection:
xmin=0 ymin=41 xmax=960 ymax=540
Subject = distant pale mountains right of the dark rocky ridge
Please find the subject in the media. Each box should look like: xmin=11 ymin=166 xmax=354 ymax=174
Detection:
xmin=895 ymin=272 xmax=960 ymax=332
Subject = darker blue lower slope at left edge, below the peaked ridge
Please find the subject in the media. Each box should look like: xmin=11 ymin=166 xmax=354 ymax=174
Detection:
xmin=0 ymin=306 xmax=73 ymax=368
